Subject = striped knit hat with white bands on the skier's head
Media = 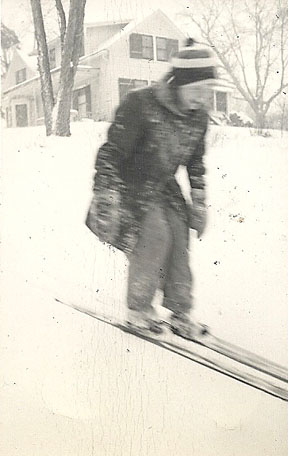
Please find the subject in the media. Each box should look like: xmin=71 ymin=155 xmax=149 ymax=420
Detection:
xmin=170 ymin=38 xmax=217 ymax=86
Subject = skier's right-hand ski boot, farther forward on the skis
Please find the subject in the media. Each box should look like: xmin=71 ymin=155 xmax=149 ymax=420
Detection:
xmin=169 ymin=312 xmax=209 ymax=341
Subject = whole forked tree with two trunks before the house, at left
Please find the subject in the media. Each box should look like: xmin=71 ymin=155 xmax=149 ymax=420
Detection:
xmin=30 ymin=0 xmax=86 ymax=136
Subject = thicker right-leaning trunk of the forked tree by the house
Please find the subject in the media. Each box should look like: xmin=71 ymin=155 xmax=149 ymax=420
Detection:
xmin=52 ymin=0 xmax=86 ymax=136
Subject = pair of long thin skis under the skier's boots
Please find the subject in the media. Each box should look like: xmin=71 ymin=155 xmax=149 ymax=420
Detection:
xmin=55 ymin=298 xmax=288 ymax=401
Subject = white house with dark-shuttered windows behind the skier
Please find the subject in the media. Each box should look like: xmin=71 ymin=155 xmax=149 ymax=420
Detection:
xmin=2 ymin=10 xmax=230 ymax=127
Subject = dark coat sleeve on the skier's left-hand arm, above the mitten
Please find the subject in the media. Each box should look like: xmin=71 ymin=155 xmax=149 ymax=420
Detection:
xmin=95 ymin=92 xmax=144 ymax=185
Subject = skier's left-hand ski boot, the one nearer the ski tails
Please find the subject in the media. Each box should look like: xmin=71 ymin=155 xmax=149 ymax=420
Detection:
xmin=126 ymin=308 xmax=163 ymax=335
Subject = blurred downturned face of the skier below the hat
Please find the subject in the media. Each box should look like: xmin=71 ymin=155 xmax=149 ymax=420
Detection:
xmin=178 ymin=83 xmax=212 ymax=110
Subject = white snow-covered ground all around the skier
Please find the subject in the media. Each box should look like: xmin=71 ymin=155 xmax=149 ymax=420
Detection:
xmin=0 ymin=122 xmax=288 ymax=456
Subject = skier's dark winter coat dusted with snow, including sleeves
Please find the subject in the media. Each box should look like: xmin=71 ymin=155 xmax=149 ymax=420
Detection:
xmin=86 ymin=76 xmax=208 ymax=252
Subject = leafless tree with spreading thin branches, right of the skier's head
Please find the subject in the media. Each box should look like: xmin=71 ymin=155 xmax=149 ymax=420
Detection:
xmin=183 ymin=0 xmax=288 ymax=129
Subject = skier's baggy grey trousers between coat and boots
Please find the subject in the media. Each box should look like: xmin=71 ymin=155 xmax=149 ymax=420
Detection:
xmin=127 ymin=202 xmax=192 ymax=313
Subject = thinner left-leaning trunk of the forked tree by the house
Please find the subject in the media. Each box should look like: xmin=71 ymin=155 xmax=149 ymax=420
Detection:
xmin=30 ymin=0 xmax=54 ymax=136
